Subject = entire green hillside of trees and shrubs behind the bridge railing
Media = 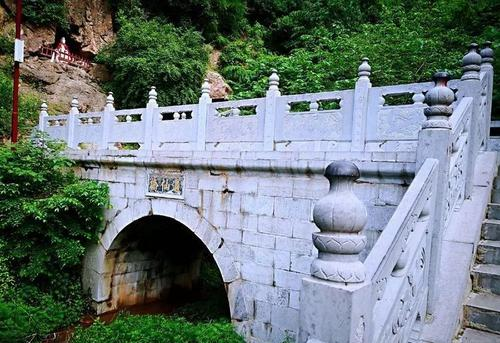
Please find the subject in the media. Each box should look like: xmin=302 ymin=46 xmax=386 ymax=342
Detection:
xmin=102 ymin=0 xmax=500 ymax=112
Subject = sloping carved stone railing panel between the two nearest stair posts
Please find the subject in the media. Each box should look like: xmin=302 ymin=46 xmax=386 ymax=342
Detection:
xmin=364 ymin=159 xmax=438 ymax=343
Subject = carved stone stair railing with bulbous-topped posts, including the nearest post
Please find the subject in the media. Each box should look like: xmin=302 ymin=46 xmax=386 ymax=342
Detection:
xmin=298 ymin=44 xmax=493 ymax=343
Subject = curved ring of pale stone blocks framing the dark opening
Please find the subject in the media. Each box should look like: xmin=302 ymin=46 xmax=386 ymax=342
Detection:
xmin=82 ymin=198 xmax=252 ymax=321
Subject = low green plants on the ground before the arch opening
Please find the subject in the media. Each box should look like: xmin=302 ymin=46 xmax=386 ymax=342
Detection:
xmin=71 ymin=315 xmax=244 ymax=343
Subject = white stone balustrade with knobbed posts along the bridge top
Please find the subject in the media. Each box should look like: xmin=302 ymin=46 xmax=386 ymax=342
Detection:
xmin=39 ymin=49 xmax=491 ymax=153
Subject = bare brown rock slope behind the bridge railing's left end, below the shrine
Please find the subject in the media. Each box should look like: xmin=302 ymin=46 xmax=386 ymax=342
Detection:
xmin=21 ymin=57 xmax=106 ymax=112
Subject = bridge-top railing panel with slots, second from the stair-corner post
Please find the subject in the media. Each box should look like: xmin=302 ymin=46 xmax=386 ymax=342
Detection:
xmin=275 ymin=90 xmax=354 ymax=141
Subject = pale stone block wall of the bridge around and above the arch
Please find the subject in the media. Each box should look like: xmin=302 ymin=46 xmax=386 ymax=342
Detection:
xmin=80 ymin=152 xmax=413 ymax=343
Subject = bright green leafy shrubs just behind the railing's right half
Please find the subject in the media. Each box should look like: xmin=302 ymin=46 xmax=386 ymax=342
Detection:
xmin=221 ymin=1 xmax=498 ymax=103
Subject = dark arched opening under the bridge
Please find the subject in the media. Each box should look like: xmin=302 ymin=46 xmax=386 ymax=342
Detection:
xmin=105 ymin=215 xmax=230 ymax=320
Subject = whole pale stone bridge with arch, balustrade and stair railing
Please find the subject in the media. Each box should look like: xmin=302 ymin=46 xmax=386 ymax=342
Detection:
xmin=39 ymin=44 xmax=495 ymax=343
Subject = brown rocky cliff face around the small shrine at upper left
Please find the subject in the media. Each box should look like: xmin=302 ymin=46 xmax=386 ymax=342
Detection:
xmin=0 ymin=0 xmax=114 ymax=112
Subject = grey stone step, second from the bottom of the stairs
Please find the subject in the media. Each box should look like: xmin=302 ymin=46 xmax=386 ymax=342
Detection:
xmin=464 ymin=293 xmax=500 ymax=334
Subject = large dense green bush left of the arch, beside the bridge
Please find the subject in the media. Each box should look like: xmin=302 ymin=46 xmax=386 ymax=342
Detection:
xmin=0 ymin=141 xmax=107 ymax=343
